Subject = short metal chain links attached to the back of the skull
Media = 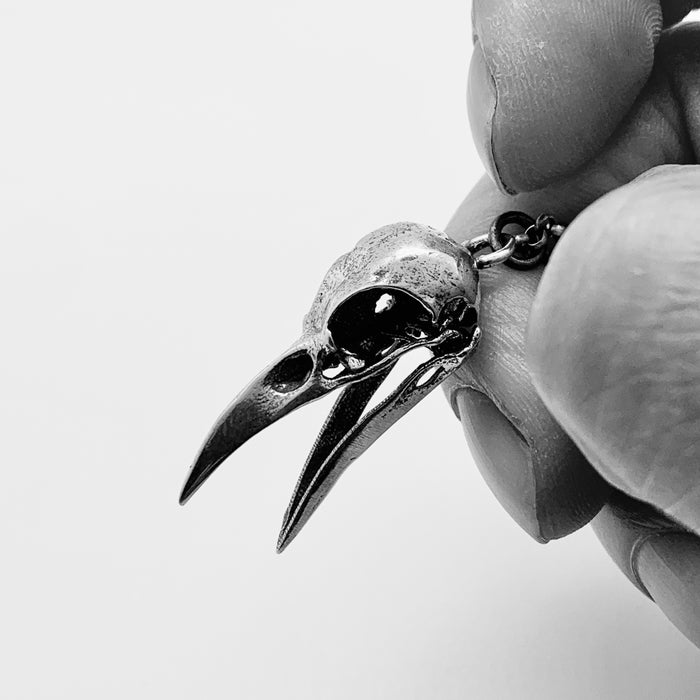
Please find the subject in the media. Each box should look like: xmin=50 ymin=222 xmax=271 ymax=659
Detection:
xmin=463 ymin=211 xmax=565 ymax=270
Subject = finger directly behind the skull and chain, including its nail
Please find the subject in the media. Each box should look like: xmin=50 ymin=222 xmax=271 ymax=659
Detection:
xmin=445 ymin=177 xmax=608 ymax=542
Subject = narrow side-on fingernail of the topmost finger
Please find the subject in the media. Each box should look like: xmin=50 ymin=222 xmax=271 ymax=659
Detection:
xmin=467 ymin=40 xmax=515 ymax=194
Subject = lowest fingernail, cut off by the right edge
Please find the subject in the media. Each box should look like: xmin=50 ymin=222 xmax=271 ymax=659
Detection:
xmin=634 ymin=533 xmax=700 ymax=646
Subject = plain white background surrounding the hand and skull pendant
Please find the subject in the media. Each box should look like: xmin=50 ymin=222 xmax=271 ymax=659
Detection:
xmin=0 ymin=0 xmax=700 ymax=700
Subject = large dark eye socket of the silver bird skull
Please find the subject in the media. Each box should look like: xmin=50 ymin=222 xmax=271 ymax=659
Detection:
xmin=328 ymin=287 xmax=434 ymax=360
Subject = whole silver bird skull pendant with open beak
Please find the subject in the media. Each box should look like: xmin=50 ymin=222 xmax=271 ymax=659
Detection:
xmin=180 ymin=223 xmax=480 ymax=551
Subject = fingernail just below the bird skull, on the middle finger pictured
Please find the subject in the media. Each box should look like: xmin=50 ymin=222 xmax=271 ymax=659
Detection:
xmin=454 ymin=388 xmax=546 ymax=542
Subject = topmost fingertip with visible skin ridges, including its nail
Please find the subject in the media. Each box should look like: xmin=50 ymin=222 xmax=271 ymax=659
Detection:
xmin=469 ymin=0 xmax=661 ymax=192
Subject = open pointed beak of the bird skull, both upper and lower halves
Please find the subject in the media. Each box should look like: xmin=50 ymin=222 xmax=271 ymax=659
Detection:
xmin=180 ymin=329 xmax=480 ymax=552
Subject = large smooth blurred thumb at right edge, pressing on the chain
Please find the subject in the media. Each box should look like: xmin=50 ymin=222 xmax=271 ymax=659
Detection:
xmin=527 ymin=166 xmax=700 ymax=533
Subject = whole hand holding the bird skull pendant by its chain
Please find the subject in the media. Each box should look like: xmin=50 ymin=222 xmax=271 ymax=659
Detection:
xmin=446 ymin=0 xmax=700 ymax=646
